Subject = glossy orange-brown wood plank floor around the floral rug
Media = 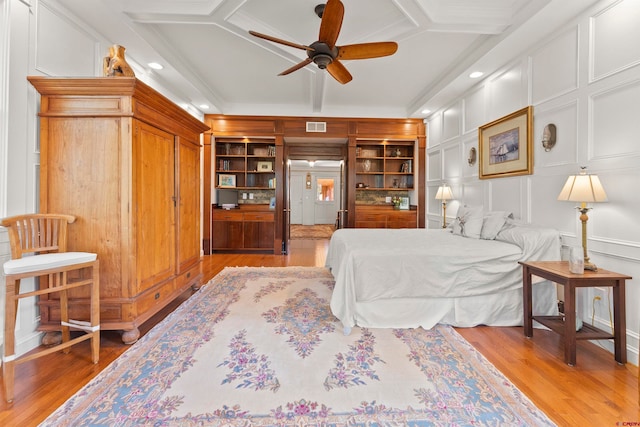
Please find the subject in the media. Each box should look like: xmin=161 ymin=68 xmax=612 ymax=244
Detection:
xmin=0 ymin=240 xmax=640 ymax=427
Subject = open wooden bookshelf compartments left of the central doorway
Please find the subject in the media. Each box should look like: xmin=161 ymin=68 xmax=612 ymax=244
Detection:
xmin=214 ymin=138 xmax=276 ymax=190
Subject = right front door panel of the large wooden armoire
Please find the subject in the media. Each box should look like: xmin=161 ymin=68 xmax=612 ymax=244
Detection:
xmin=176 ymin=138 xmax=200 ymax=274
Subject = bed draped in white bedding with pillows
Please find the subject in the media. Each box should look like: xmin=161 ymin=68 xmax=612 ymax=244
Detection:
xmin=326 ymin=208 xmax=561 ymax=334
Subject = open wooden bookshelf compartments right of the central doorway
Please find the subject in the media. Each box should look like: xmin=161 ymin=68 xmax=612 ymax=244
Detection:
xmin=356 ymin=141 xmax=414 ymax=191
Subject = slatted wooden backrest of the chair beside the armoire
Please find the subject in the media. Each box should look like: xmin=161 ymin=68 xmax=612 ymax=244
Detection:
xmin=0 ymin=214 xmax=76 ymax=259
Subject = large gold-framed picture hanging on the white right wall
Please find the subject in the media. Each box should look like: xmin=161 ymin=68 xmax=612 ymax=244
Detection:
xmin=478 ymin=106 xmax=533 ymax=179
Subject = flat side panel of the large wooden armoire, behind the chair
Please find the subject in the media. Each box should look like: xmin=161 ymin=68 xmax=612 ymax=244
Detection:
xmin=40 ymin=117 xmax=125 ymax=298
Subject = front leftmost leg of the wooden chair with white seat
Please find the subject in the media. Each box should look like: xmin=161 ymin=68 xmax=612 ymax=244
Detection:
xmin=2 ymin=276 xmax=20 ymax=402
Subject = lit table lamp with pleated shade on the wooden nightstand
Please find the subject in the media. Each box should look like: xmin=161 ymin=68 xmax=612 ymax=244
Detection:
xmin=558 ymin=167 xmax=607 ymax=271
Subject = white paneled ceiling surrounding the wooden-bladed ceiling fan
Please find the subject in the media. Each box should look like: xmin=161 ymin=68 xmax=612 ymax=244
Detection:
xmin=48 ymin=0 xmax=593 ymax=117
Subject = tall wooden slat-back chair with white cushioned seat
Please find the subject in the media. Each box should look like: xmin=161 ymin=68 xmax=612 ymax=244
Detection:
xmin=0 ymin=214 xmax=100 ymax=402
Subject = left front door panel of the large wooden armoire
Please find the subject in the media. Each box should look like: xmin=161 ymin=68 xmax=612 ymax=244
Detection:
xmin=132 ymin=120 xmax=176 ymax=294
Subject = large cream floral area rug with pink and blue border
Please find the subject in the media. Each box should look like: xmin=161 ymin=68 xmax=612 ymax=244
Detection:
xmin=42 ymin=267 xmax=553 ymax=426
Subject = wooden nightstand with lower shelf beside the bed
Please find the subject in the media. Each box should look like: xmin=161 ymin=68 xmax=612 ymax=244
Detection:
xmin=520 ymin=261 xmax=631 ymax=366
